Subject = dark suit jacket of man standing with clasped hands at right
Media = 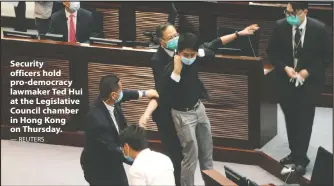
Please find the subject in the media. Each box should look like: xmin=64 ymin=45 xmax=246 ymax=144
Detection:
xmin=267 ymin=17 xmax=333 ymax=102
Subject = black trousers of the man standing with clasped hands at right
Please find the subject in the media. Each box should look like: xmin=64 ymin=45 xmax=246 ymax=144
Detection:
xmin=280 ymin=89 xmax=315 ymax=166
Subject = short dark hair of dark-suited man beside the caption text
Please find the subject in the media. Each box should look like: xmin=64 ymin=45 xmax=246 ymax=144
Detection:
xmin=99 ymin=74 xmax=119 ymax=100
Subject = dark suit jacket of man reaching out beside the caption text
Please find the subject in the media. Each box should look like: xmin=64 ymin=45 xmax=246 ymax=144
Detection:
xmin=81 ymin=90 xmax=139 ymax=185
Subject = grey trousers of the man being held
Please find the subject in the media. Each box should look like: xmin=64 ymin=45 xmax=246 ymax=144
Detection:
xmin=171 ymin=102 xmax=213 ymax=186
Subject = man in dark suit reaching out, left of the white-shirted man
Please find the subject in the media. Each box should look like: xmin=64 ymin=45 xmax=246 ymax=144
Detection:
xmin=80 ymin=75 xmax=158 ymax=186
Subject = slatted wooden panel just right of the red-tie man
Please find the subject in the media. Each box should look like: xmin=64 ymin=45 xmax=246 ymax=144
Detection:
xmin=96 ymin=8 xmax=119 ymax=39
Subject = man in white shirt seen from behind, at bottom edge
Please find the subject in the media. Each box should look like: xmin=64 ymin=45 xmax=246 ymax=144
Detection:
xmin=120 ymin=125 xmax=175 ymax=186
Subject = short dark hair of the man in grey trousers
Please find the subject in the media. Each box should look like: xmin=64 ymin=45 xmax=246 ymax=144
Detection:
xmin=177 ymin=32 xmax=199 ymax=52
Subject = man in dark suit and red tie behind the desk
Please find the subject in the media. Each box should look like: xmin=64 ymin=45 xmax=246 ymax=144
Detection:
xmin=49 ymin=1 xmax=100 ymax=43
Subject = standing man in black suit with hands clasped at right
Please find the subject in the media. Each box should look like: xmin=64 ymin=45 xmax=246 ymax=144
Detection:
xmin=267 ymin=2 xmax=333 ymax=175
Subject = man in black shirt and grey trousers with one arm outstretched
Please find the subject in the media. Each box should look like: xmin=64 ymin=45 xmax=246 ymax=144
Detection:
xmin=158 ymin=25 xmax=259 ymax=186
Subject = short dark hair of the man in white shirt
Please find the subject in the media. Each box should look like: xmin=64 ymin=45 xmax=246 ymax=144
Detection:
xmin=120 ymin=125 xmax=148 ymax=151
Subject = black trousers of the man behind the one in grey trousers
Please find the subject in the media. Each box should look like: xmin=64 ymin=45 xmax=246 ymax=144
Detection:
xmin=155 ymin=111 xmax=183 ymax=186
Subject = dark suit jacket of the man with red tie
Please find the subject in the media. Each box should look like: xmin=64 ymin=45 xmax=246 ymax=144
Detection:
xmin=49 ymin=8 xmax=102 ymax=43
